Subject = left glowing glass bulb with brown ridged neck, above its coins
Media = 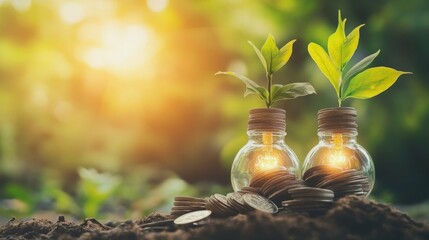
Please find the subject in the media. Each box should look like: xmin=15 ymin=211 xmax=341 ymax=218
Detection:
xmin=231 ymin=108 xmax=300 ymax=191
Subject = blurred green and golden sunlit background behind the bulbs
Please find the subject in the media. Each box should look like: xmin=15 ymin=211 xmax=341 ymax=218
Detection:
xmin=0 ymin=0 xmax=429 ymax=222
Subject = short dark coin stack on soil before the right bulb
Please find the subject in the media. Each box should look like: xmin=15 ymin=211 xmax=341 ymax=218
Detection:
xmin=282 ymin=187 xmax=334 ymax=214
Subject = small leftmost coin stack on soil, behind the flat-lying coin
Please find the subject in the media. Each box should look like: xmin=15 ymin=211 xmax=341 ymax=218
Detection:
xmin=171 ymin=196 xmax=206 ymax=217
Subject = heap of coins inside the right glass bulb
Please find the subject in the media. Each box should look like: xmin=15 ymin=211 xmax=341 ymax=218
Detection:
xmin=303 ymin=165 xmax=370 ymax=199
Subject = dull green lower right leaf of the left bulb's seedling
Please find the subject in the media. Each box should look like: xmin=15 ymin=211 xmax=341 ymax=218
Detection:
xmin=271 ymin=83 xmax=316 ymax=103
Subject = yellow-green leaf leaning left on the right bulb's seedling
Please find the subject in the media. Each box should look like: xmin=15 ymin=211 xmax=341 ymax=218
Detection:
xmin=308 ymin=43 xmax=341 ymax=96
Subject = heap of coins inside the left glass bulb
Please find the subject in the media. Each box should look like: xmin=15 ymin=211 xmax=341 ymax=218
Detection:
xmin=249 ymin=168 xmax=303 ymax=203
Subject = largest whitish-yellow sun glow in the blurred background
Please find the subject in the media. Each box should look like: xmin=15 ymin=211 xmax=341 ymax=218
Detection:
xmin=83 ymin=24 xmax=156 ymax=71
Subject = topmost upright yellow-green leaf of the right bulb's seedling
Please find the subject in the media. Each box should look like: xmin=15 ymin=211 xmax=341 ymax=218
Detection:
xmin=328 ymin=10 xmax=346 ymax=70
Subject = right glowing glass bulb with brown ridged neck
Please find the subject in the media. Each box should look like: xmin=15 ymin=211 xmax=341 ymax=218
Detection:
xmin=302 ymin=108 xmax=375 ymax=197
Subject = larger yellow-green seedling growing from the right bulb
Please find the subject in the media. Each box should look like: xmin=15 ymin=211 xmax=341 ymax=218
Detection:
xmin=308 ymin=11 xmax=411 ymax=107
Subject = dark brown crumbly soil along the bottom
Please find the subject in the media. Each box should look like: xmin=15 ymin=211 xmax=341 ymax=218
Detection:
xmin=0 ymin=197 xmax=429 ymax=240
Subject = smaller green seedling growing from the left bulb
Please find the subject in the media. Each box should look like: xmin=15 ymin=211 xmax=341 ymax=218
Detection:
xmin=215 ymin=34 xmax=316 ymax=108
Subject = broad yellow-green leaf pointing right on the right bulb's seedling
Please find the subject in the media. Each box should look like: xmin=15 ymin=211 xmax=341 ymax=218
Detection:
xmin=343 ymin=67 xmax=411 ymax=100
